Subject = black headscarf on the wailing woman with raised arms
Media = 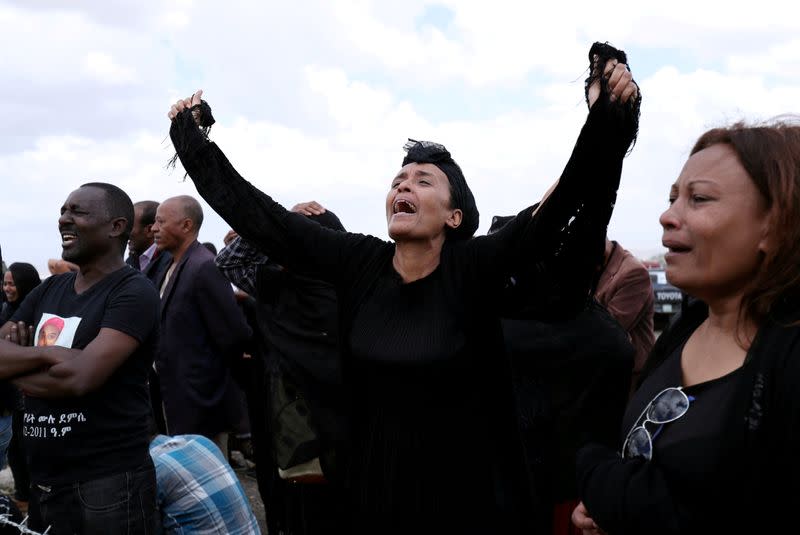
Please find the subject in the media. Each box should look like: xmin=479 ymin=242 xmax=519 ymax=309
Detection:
xmin=403 ymin=139 xmax=480 ymax=240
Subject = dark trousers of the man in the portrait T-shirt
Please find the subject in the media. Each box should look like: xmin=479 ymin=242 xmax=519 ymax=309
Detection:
xmin=29 ymin=455 xmax=158 ymax=535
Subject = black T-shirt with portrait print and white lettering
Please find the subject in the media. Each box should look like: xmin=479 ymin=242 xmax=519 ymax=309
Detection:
xmin=12 ymin=266 xmax=158 ymax=484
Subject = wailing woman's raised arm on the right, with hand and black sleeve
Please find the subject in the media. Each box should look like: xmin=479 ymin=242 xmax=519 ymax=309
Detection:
xmin=470 ymin=43 xmax=641 ymax=316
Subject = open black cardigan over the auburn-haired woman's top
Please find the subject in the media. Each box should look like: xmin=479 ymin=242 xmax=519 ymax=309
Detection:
xmin=577 ymin=302 xmax=800 ymax=535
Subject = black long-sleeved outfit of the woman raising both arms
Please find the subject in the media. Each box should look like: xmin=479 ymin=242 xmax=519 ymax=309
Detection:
xmin=170 ymin=96 xmax=633 ymax=533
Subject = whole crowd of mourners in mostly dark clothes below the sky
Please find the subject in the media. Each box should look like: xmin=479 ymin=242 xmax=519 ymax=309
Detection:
xmin=0 ymin=43 xmax=800 ymax=535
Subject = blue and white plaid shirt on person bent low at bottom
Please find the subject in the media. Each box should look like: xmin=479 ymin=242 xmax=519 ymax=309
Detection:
xmin=150 ymin=435 xmax=261 ymax=535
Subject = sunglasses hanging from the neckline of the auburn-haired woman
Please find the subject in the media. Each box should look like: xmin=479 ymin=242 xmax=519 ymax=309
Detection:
xmin=622 ymin=386 xmax=694 ymax=461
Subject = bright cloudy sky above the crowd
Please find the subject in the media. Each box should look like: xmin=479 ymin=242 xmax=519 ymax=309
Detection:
xmin=0 ymin=0 xmax=800 ymax=274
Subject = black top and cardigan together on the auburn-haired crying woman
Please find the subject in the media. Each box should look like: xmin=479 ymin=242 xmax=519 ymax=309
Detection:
xmin=577 ymin=302 xmax=800 ymax=535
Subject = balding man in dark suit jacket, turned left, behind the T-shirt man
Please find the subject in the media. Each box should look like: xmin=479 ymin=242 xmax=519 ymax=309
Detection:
xmin=153 ymin=195 xmax=252 ymax=451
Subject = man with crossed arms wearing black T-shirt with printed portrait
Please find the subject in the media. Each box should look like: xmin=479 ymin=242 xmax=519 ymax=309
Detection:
xmin=0 ymin=183 xmax=159 ymax=535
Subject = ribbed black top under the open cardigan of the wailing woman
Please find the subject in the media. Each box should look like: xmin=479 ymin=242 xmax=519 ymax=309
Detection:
xmin=348 ymin=263 xmax=500 ymax=528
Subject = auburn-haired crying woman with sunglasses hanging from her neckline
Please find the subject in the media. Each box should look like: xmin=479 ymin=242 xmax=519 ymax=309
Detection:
xmin=573 ymin=119 xmax=800 ymax=535
